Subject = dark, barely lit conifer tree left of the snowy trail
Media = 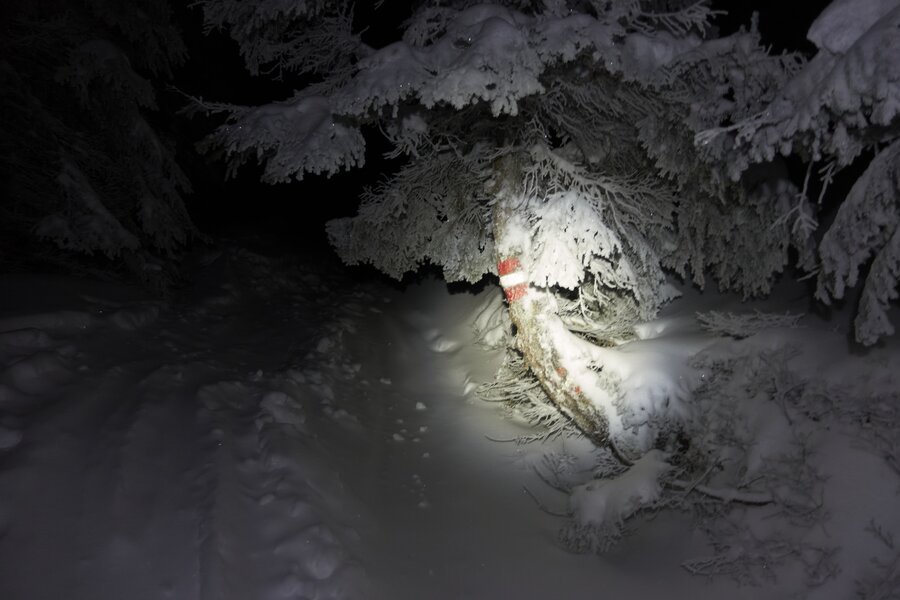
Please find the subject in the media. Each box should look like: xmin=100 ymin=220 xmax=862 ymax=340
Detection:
xmin=0 ymin=0 xmax=193 ymax=286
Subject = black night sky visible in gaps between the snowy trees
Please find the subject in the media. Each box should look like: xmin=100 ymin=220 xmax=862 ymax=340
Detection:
xmin=170 ymin=0 xmax=829 ymax=250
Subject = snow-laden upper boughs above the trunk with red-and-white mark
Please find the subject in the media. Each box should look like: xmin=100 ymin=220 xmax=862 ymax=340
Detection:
xmin=204 ymin=1 xmax=709 ymax=182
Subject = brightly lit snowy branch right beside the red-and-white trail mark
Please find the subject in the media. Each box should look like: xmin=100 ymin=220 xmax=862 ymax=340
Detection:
xmin=523 ymin=144 xmax=674 ymax=314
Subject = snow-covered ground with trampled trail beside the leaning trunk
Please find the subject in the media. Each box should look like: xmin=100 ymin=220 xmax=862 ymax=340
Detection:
xmin=0 ymin=244 xmax=900 ymax=600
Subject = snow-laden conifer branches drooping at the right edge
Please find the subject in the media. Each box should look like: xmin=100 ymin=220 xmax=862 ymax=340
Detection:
xmin=695 ymin=0 xmax=900 ymax=345
